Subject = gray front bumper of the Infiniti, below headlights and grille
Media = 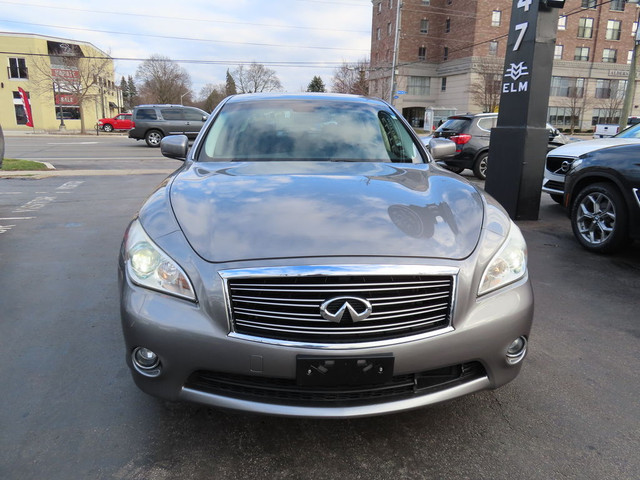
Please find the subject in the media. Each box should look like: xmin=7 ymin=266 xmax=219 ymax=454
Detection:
xmin=120 ymin=264 xmax=533 ymax=418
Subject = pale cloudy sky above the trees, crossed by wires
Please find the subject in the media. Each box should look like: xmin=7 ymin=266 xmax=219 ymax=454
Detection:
xmin=0 ymin=0 xmax=372 ymax=97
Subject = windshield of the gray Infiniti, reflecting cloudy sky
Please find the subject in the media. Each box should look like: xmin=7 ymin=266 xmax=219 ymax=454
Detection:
xmin=198 ymin=99 xmax=423 ymax=163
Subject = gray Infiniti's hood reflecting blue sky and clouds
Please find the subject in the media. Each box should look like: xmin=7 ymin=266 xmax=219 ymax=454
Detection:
xmin=170 ymin=162 xmax=484 ymax=262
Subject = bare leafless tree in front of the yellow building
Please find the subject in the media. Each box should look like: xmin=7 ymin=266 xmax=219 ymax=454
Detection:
xmin=31 ymin=51 xmax=113 ymax=133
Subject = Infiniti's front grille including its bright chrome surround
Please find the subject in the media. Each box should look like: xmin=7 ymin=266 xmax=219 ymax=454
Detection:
xmin=219 ymin=265 xmax=459 ymax=349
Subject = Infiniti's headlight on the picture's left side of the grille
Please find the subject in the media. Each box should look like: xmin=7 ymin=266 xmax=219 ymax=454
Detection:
xmin=125 ymin=220 xmax=196 ymax=301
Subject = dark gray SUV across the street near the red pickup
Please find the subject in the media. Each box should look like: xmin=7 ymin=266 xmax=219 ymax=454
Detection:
xmin=129 ymin=104 xmax=209 ymax=147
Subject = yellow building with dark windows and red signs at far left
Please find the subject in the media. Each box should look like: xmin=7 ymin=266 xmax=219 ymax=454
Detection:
xmin=0 ymin=32 xmax=122 ymax=132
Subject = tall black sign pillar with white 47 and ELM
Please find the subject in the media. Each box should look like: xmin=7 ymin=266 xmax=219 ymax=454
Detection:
xmin=485 ymin=0 xmax=564 ymax=220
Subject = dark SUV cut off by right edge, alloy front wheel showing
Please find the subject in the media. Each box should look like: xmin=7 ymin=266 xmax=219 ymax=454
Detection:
xmin=564 ymin=143 xmax=640 ymax=253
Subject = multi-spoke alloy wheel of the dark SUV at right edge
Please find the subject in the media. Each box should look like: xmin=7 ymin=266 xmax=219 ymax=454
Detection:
xmin=571 ymin=183 xmax=627 ymax=253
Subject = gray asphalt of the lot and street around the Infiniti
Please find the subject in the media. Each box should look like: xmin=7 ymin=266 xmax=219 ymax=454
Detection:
xmin=0 ymin=137 xmax=640 ymax=480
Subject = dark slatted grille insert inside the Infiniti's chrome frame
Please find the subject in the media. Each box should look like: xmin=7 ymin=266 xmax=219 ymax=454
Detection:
xmin=223 ymin=273 xmax=455 ymax=344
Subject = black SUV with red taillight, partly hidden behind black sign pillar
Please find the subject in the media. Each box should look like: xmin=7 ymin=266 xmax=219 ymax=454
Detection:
xmin=433 ymin=113 xmax=569 ymax=180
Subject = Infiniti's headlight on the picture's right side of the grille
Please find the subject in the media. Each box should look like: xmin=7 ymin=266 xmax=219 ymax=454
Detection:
xmin=478 ymin=222 xmax=527 ymax=295
